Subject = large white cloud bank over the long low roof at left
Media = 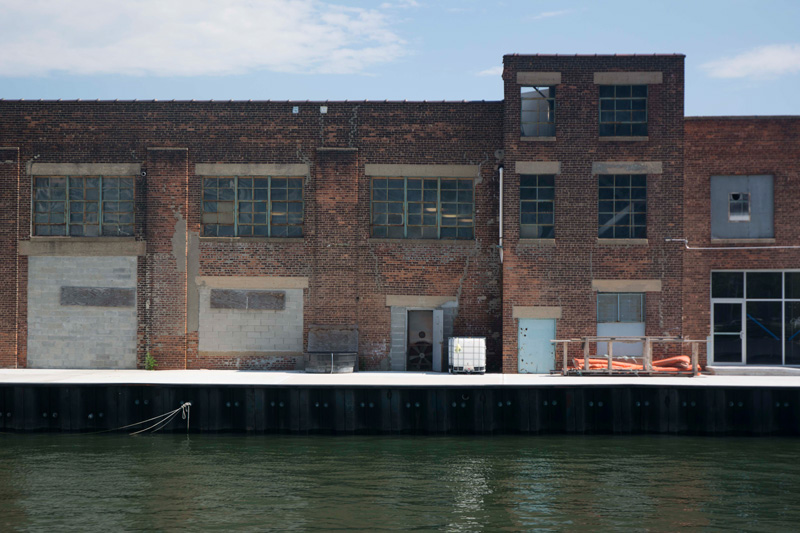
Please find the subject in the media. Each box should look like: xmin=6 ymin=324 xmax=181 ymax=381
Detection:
xmin=0 ymin=0 xmax=406 ymax=76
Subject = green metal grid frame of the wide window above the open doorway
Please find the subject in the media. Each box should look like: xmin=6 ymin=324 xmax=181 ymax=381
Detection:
xmin=369 ymin=176 xmax=476 ymax=241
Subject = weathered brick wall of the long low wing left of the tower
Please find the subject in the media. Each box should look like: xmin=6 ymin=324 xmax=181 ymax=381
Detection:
xmin=0 ymin=102 xmax=502 ymax=370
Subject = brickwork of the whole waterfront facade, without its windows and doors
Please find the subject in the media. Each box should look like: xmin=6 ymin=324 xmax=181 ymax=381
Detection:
xmin=0 ymin=55 xmax=800 ymax=373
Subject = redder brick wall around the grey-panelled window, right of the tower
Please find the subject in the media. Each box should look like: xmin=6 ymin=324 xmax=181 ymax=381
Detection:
xmin=683 ymin=117 xmax=800 ymax=362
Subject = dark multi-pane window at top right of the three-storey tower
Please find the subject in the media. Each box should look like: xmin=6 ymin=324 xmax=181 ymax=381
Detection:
xmin=600 ymin=85 xmax=647 ymax=137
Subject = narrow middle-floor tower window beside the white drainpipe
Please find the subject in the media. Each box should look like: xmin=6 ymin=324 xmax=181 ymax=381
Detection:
xmin=519 ymin=175 xmax=555 ymax=239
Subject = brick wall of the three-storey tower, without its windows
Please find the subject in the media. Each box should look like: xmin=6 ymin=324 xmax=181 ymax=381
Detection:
xmin=502 ymin=55 xmax=684 ymax=372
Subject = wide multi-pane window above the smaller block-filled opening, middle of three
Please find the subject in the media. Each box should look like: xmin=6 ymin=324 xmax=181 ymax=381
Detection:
xmin=203 ymin=176 xmax=303 ymax=237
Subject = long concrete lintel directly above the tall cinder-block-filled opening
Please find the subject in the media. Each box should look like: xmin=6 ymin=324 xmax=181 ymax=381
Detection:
xmin=19 ymin=237 xmax=147 ymax=257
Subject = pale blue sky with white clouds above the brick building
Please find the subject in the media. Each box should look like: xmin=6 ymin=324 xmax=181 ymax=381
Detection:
xmin=0 ymin=0 xmax=800 ymax=116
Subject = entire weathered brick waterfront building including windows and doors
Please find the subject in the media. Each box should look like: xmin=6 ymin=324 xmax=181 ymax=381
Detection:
xmin=0 ymin=55 xmax=800 ymax=372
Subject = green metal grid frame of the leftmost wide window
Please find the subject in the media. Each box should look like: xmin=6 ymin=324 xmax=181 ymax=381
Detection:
xmin=30 ymin=174 xmax=137 ymax=239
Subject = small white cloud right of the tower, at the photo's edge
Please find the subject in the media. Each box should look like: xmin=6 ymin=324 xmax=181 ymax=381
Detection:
xmin=701 ymin=44 xmax=800 ymax=78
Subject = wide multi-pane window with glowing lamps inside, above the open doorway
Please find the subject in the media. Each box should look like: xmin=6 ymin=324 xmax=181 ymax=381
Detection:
xmin=371 ymin=178 xmax=475 ymax=239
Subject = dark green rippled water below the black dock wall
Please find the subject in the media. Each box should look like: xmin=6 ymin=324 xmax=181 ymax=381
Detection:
xmin=0 ymin=435 xmax=800 ymax=532
